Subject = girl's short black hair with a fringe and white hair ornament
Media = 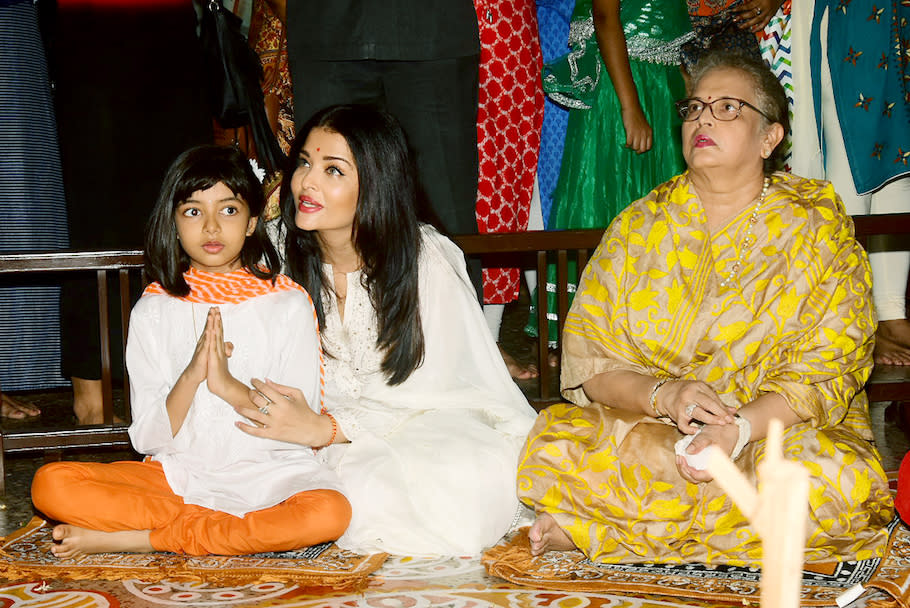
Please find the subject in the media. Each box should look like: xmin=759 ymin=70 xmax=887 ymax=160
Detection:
xmin=145 ymin=145 xmax=281 ymax=297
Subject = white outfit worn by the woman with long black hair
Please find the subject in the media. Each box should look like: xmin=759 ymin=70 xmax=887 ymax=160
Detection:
xmin=323 ymin=227 xmax=535 ymax=555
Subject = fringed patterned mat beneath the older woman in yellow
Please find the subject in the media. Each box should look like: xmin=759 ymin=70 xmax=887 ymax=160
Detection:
xmin=483 ymin=521 xmax=910 ymax=608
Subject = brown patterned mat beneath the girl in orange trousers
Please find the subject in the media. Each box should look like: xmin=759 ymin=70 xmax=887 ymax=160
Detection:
xmin=0 ymin=517 xmax=388 ymax=589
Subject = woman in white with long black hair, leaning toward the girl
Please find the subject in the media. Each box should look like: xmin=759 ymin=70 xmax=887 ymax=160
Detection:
xmin=235 ymin=106 xmax=534 ymax=555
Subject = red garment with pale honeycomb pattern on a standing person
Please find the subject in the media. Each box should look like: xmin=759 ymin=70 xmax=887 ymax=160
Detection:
xmin=474 ymin=0 xmax=544 ymax=304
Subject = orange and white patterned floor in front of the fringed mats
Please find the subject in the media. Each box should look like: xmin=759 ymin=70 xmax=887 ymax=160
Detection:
xmin=0 ymin=544 xmax=896 ymax=608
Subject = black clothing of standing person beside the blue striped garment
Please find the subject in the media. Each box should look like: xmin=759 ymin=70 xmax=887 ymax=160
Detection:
xmin=51 ymin=2 xmax=212 ymax=379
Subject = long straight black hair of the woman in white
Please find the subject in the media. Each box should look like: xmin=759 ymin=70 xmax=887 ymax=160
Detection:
xmin=281 ymin=105 xmax=424 ymax=385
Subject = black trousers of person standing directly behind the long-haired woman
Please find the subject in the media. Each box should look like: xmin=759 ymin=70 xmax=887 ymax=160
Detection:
xmin=290 ymin=55 xmax=481 ymax=293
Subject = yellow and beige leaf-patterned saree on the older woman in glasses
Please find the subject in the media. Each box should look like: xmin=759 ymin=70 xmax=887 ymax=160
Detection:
xmin=518 ymin=173 xmax=893 ymax=565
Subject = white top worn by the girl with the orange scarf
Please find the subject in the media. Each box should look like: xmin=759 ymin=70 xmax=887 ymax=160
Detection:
xmin=126 ymin=282 xmax=340 ymax=517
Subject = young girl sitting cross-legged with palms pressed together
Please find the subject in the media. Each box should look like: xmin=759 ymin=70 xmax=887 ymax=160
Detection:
xmin=32 ymin=146 xmax=351 ymax=557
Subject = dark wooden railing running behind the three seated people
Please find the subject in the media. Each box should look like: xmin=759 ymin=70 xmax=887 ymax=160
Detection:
xmin=0 ymin=213 xmax=910 ymax=492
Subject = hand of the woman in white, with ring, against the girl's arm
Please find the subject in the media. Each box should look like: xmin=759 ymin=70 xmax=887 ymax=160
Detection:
xmin=234 ymin=378 xmax=328 ymax=447
